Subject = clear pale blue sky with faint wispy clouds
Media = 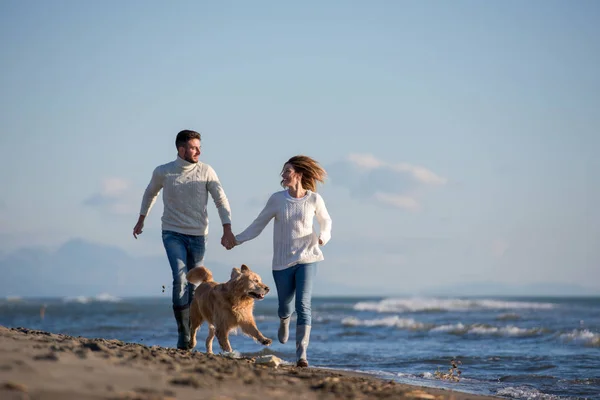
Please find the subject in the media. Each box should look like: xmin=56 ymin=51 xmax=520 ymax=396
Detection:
xmin=0 ymin=0 xmax=600 ymax=293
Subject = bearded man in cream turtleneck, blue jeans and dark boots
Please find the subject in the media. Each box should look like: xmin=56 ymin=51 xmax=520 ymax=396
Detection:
xmin=133 ymin=130 xmax=235 ymax=349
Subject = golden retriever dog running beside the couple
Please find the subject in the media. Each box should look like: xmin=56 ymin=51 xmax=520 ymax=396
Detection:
xmin=186 ymin=265 xmax=272 ymax=354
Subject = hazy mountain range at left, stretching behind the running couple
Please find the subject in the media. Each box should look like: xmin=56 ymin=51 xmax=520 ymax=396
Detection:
xmin=0 ymin=239 xmax=352 ymax=297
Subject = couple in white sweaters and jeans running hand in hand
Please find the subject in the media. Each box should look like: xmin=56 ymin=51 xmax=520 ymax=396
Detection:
xmin=133 ymin=130 xmax=331 ymax=366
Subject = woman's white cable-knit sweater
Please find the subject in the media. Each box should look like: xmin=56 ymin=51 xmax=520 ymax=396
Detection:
xmin=235 ymin=190 xmax=331 ymax=271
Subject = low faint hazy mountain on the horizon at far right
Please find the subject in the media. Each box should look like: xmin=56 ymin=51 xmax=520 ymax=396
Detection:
xmin=419 ymin=282 xmax=600 ymax=297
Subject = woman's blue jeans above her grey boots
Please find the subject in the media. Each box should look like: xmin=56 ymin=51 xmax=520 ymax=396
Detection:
xmin=273 ymin=263 xmax=317 ymax=326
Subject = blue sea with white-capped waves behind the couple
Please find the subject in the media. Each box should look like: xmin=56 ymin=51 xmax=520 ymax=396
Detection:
xmin=0 ymin=293 xmax=600 ymax=399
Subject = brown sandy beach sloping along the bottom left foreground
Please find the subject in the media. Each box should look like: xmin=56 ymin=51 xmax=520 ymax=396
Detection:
xmin=0 ymin=326 xmax=500 ymax=400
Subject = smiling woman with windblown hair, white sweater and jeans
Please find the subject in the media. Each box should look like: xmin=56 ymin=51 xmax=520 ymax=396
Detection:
xmin=235 ymin=155 xmax=331 ymax=367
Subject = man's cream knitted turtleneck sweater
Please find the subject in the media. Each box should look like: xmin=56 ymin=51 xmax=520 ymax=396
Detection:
xmin=140 ymin=156 xmax=231 ymax=236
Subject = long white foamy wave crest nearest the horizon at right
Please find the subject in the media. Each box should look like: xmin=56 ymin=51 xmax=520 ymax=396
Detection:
xmin=354 ymin=297 xmax=555 ymax=313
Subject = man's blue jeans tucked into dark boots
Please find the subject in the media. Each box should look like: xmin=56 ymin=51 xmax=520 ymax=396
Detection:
xmin=162 ymin=231 xmax=206 ymax=310
